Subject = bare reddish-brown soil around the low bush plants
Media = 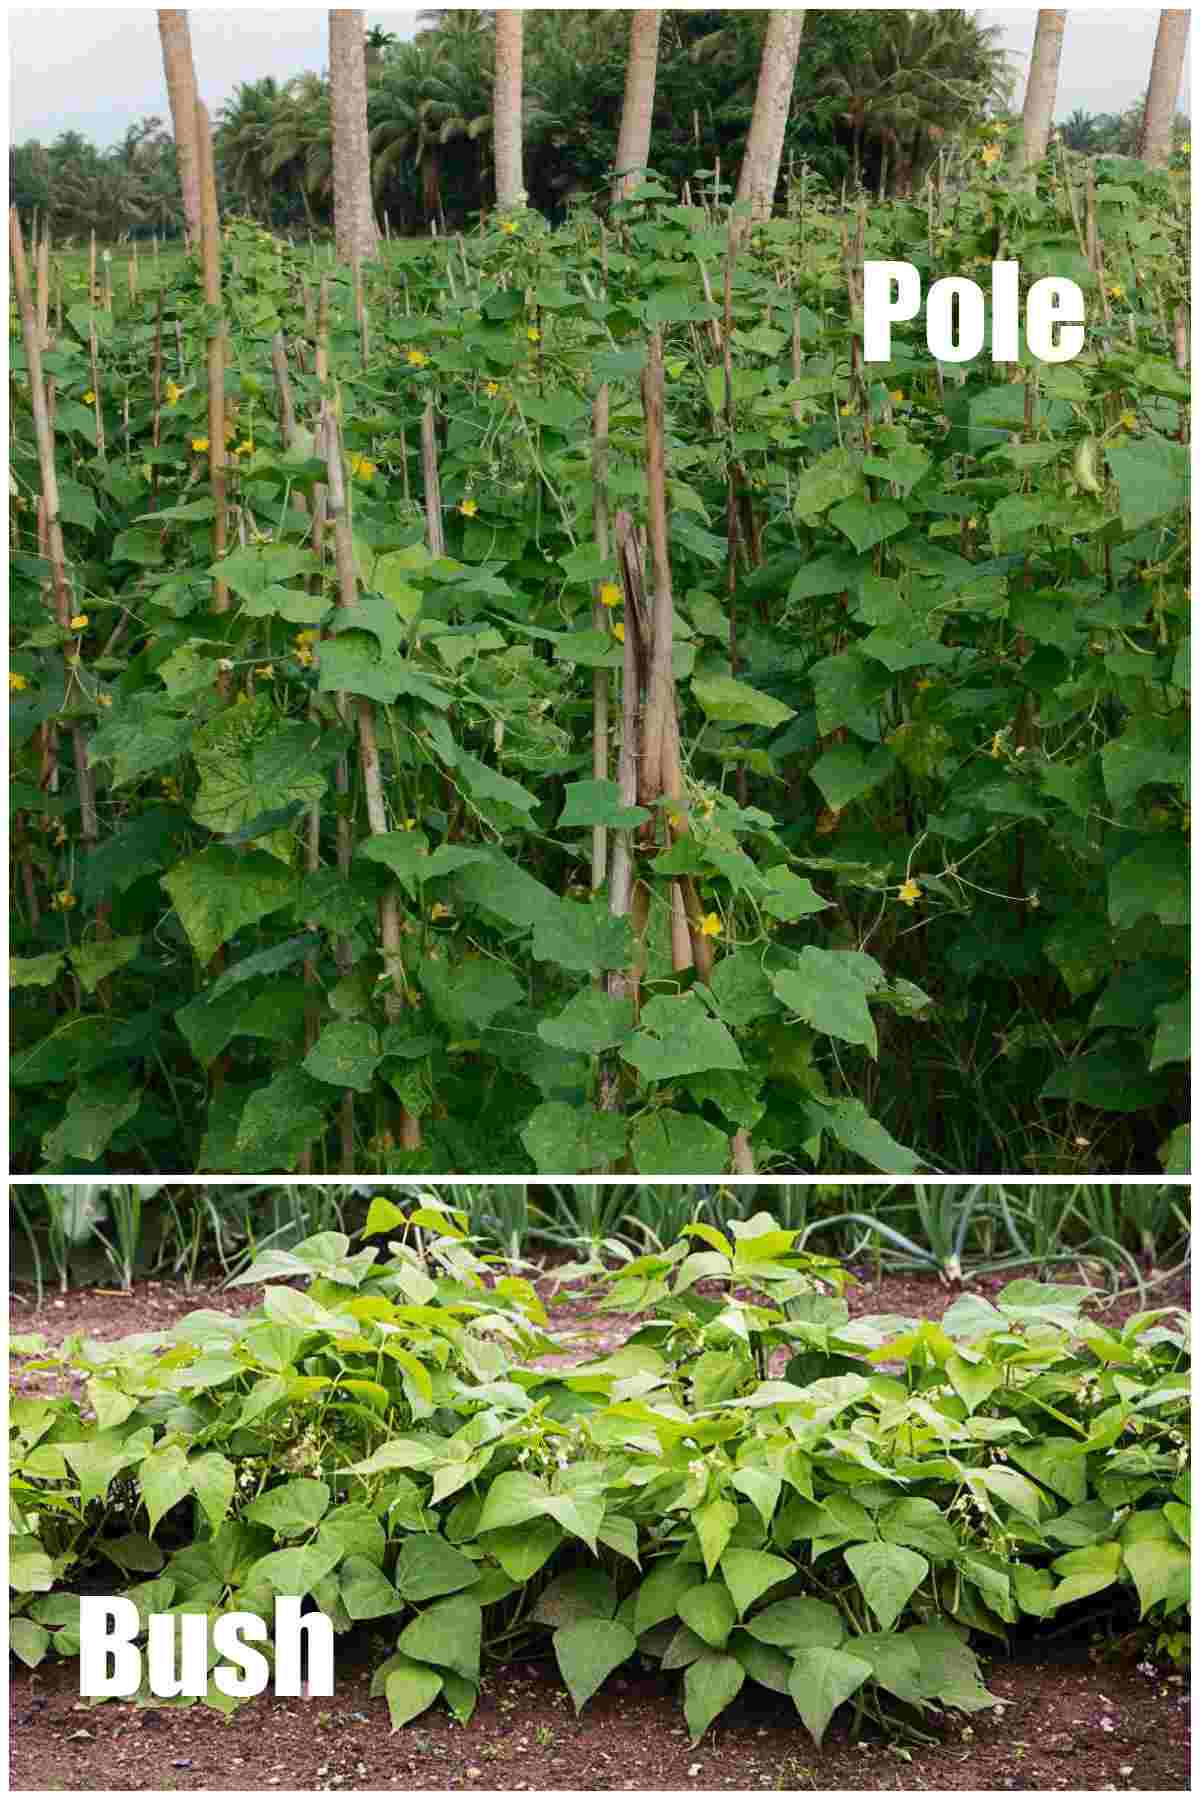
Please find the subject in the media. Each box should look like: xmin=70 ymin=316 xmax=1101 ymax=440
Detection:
xmin=9 ymin=1269 xmax=1191 ymax=1793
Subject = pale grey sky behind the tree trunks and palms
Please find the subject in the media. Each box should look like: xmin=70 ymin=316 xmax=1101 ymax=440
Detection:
xmin=7 ymin=5 xmax=1191 ymax=148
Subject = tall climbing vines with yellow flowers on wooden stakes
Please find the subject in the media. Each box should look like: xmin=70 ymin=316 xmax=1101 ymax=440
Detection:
xmin=11 ymin=146 xmax=1189 ymax=1177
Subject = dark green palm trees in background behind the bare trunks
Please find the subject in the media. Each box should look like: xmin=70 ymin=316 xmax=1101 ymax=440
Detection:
xmin=9 ymin=7 xmax=1021 ymax=238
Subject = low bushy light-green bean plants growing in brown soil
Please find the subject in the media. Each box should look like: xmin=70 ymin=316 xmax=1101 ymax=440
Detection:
xmin=9 ymin=1197 xmax=1189 ymax=1742
